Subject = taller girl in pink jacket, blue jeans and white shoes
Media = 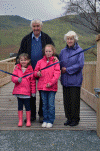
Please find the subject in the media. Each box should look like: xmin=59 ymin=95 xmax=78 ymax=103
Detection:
xmin=34 ymin=44 xmax=60 ymax=128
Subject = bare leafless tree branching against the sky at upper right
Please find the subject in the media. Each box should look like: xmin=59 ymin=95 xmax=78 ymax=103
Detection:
xmin=61 ymin=0 xmax=100 ymax=33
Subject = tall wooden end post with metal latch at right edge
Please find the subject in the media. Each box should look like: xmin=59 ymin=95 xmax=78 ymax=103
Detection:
xmin=96 ymin=34 xmax=100 ymax=137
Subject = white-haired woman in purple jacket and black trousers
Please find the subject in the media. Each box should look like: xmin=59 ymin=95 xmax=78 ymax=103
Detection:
xmin=59 ymin=31 xmax=84 ymax=126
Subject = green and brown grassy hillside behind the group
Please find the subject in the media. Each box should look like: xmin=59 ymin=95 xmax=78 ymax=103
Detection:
xmin=0 ymin=16 xmax=96 ymax=61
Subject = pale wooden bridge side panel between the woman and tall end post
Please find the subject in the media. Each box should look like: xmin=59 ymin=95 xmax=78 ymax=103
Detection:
xmin=81 ymin=62 xmax=97 ymax=111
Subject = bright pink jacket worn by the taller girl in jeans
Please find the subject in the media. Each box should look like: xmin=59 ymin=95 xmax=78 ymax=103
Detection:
xmin=34 ymin=56 xmax=60 ymax=91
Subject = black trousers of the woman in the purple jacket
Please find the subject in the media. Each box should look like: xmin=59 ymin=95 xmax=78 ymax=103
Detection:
xmin=63 ymin=86 xmax=80 ymax=122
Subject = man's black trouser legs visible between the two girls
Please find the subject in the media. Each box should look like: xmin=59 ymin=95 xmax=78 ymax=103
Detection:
xmin=30 ymin=91 xmax=43 ymax=118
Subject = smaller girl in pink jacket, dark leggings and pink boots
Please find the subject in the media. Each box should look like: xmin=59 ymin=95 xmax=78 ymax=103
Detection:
xmin=12 ymin=53 xmax=36 ymax=127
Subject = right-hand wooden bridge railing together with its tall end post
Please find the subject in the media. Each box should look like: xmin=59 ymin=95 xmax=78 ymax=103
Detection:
xmin=81 ymin=34 xmax=100 ymax=137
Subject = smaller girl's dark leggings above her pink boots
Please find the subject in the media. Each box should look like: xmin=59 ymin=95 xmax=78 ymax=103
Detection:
xmin=17 ymin=98 xmax=31 ymax=111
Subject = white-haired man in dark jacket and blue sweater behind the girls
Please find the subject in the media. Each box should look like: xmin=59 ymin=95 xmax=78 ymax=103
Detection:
xmin=16 ymin=20 xmax=54 ymax=123
